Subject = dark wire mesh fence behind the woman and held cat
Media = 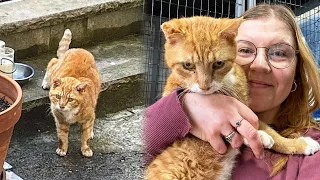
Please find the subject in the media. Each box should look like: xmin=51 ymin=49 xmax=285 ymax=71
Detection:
xmin=143 ymin=0 xmax=320 ymax=114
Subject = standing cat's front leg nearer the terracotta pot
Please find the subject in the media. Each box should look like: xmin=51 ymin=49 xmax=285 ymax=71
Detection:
xmin=56 ymin=120 xmax=70 ymax=156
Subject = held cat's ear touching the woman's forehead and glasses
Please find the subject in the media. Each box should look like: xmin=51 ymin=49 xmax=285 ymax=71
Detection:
xmin=219 ymin=18 xmax=243 ymax=41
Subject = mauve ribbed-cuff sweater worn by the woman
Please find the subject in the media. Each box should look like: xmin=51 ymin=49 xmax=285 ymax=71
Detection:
xmin=143 ymin=91 xmax=320 ymax=180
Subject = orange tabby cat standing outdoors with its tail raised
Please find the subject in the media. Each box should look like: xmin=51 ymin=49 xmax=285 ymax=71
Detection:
xmin=42 ymin=29 xmax=101 ymax=157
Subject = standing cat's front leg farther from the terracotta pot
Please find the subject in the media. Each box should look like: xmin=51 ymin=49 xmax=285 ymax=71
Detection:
xmin=81 ymin=120 xmax=93 ymax=157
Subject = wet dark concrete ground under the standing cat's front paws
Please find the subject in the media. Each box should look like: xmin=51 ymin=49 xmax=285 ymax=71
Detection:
xmin=6 ymin=106 xmax=144 ymax=180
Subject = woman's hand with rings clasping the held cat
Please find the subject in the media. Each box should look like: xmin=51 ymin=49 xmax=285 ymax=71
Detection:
xmin=181 ymin=93 xmax=264 ymax=158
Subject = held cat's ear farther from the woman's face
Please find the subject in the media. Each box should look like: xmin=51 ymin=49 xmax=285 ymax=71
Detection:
xmin=161 ymin=19 xmax=185 ymax=45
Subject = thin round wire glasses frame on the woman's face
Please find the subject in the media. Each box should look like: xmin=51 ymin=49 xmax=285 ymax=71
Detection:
xmin=237 ymin=40 xmax=300 ymax=69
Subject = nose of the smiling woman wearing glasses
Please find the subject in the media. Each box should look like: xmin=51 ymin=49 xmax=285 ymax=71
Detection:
xmin=250 ymin=49 xmax=271 ymax=72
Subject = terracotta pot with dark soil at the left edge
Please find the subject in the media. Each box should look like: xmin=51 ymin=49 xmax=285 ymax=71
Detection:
xmin=0 ymin=73 xmax=22 ymax=180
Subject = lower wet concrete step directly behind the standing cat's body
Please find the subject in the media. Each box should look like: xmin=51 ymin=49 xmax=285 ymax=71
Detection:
xmin=16 ymin=35 xmax=145 ymax=118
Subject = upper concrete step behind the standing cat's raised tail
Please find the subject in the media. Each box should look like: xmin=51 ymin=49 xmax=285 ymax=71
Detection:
xmin=0 ymin=0 xmax=142 ymax=59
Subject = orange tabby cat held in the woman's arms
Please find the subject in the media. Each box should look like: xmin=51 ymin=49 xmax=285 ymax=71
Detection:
xmin=146 ymin=17 xmax=320 ymax=180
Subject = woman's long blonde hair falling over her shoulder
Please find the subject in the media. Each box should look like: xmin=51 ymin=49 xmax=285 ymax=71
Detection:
xmin=242 ymin=4 xmax=320 ymax=175
